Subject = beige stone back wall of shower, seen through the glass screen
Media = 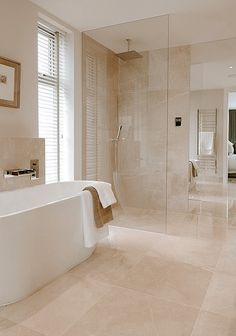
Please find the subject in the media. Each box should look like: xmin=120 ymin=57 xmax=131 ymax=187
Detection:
xmin=119 ymin=49 xmax=168 ymax=209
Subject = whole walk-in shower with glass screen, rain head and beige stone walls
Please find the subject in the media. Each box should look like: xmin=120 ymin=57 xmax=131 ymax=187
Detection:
xmin=83 ymin=16 xmax=189 ymax=232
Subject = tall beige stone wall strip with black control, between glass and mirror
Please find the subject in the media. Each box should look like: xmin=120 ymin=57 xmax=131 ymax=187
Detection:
xmin=167 ymin=46 xmax=190 ymax=211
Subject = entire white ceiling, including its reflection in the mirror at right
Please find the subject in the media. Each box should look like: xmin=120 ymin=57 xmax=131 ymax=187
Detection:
xmin=30 ymin=0 xmax=236 ymax=90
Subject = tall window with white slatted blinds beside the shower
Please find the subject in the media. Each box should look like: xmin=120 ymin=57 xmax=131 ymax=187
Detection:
xmin=38 ymin=23 xmax=67 ymax=183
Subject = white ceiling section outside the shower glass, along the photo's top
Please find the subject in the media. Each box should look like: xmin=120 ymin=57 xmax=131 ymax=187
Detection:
xmin=30 ymin=0 xmax=236 ymax=31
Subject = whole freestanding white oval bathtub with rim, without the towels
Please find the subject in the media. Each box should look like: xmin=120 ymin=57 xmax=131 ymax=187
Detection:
xmin=0 ymin=181 xmax=108 ymax=306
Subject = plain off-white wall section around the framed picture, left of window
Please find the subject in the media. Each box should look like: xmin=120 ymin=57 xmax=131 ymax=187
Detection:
xmin=0 ymin=0 xmax=38 ymax=137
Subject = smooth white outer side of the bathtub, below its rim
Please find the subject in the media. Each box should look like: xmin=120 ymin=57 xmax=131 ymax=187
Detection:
xmin=0 ymin=186 xmax=95 ymax=306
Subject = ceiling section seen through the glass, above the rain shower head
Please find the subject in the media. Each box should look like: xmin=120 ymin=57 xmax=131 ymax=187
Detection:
xmin=86 ymin=11 xmax=236 ymax=53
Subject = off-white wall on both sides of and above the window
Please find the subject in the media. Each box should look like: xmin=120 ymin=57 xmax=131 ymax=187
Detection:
xmin=0 ymin=0 xmax=82 ymax=178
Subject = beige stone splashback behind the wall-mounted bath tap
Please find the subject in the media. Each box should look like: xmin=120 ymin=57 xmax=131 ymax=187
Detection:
xmin=0 ymin=137 xmax=45 ymax=191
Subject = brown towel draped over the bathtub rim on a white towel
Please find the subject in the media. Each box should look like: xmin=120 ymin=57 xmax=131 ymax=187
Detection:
xmin=83 ymin=187 xmax=113 ymax=228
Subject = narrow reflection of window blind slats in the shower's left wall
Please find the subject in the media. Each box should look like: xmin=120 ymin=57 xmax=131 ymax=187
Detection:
xmin=85 ymin=54 xmax=97 ymax=180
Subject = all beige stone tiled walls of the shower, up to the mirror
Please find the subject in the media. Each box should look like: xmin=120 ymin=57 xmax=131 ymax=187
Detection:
xmin=83 ymin=35 xmax=190 ymax=211
